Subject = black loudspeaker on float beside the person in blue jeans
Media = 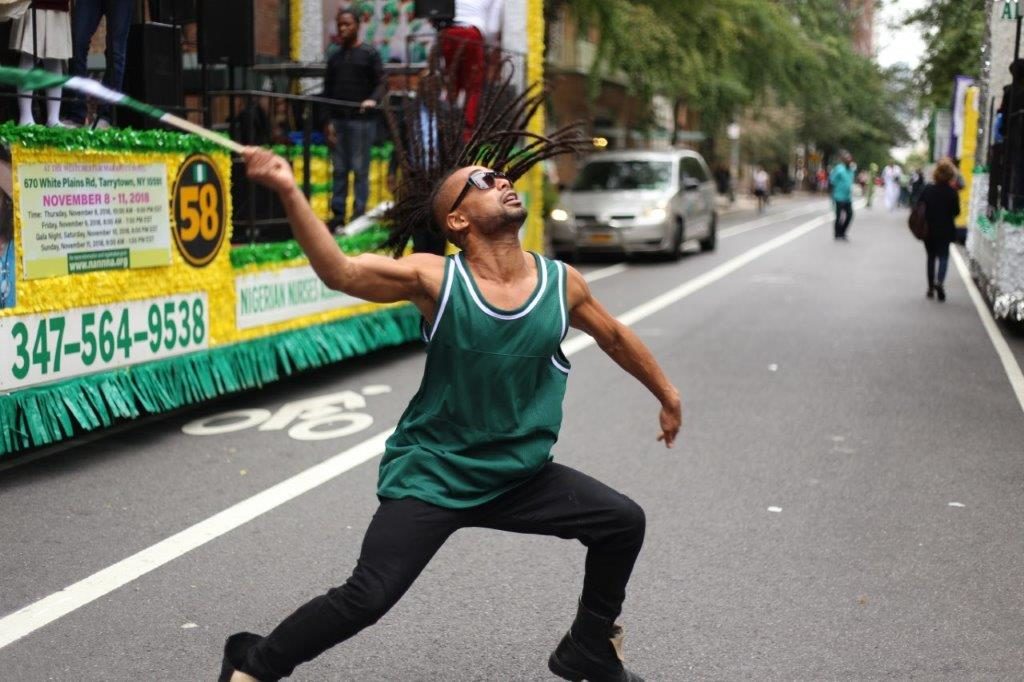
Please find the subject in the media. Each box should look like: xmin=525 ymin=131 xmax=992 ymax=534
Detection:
xmin=117 ymin=23 xmax=184 ymax=128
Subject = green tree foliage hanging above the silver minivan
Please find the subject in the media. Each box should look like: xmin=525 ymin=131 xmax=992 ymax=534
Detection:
xmin=548 ymin=0 xmax=913 ymax=162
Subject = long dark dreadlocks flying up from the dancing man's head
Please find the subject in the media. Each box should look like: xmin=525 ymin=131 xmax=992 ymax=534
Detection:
xmin=383 ymin=62 xmax=590 ymax=257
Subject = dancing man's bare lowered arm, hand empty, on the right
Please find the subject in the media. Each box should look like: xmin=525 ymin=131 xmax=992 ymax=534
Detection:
xmin=567 ymin=267 xmax=683 ymax=447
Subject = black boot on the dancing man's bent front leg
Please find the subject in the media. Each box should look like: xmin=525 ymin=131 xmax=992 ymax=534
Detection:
xmin=548 ymin=603 xmax=643 ymax=682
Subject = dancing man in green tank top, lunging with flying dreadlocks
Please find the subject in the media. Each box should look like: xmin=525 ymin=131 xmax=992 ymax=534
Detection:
xmin=220 ymin=78 xmax=681 ymax=682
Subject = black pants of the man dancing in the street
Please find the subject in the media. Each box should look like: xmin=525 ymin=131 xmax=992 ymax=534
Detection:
xmin=235 ymin=463 xmax=645 ymax=682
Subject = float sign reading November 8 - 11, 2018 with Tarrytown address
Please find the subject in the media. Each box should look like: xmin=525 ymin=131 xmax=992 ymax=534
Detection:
xmin=15 ymin=162 xmax=171 ymax=280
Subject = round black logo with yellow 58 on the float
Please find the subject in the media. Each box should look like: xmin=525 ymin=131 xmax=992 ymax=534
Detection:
xmin=173 ymin=154 xmax=227 ymax=267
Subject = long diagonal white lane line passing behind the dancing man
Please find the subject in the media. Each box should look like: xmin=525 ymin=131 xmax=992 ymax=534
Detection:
xmin=0 ymin=210 xmax=830 ymax=649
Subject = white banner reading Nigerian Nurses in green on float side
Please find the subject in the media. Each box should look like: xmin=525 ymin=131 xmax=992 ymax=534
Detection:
xmin=234 ymin=266 xmax=366 ymax=330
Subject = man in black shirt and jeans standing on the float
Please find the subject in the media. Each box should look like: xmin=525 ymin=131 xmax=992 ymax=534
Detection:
xmin=324 ymin=9 xmax=385 ymax=227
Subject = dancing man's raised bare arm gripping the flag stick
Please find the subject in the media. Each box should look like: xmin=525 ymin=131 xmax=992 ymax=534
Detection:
xmin=242 ymin=146 xmax=443 ymax=314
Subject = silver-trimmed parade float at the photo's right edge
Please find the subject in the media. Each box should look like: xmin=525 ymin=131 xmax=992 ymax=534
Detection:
xmin=962 ymin=0 xmax=1024 ymax=322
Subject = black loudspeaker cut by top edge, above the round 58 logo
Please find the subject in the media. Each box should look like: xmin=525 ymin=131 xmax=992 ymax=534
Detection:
xmin=199 ymin=0 xmax=256 ymax=67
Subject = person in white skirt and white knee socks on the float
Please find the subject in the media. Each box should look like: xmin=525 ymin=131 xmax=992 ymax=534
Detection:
xmin=10 ymin=0 xmax=71 ymax=126
